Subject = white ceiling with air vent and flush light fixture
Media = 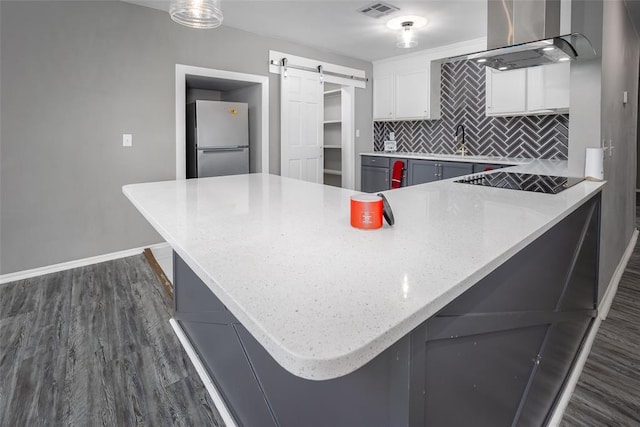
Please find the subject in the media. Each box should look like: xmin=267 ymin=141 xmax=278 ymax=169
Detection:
xmin=125 ymin=0 xmax=487 ymax=61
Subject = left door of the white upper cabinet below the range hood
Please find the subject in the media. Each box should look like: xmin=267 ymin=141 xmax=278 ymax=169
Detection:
xmin=486 ymin=67 xmax=527 ymax=116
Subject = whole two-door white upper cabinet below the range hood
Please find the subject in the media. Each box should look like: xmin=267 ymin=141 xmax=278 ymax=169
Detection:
xmin=486 ymin=63 xmax=570 ymax=116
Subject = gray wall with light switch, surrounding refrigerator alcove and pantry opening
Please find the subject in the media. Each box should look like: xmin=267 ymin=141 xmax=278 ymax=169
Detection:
xmin=0 ymin=1 xmax=373 ymax=274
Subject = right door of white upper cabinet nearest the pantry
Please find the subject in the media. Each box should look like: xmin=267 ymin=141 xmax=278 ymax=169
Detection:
xmin=396 ymin=70 xmax=429 ymax=119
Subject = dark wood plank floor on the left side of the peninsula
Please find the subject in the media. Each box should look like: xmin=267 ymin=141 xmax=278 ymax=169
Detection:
xmin=0 ymin=255 xmax=223 ymax=426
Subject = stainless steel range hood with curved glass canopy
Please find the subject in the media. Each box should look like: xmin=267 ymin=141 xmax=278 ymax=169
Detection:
xmin=444 ymin=0 xmax=596 ymax=71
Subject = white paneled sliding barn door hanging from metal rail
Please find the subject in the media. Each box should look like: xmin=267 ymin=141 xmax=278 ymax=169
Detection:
xmin=280 ymin=69 xmax=324 ymax=183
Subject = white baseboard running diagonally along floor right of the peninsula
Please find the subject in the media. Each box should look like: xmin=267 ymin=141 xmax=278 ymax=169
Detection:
xmin=548 ymin=230 xmax=638 ymax=427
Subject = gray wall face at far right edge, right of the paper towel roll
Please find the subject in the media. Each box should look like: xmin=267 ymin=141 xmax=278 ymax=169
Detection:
xmin=600 ymin=0 xmax=640 ymax=296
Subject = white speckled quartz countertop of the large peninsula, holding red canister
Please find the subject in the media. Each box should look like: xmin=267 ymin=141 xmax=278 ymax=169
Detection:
xmin=123 ymin=166 xmax=603 ymax=380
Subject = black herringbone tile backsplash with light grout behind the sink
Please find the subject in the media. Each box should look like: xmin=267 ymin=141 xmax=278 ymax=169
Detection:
xmin=374 ymin=61 xmax=569 ymax=160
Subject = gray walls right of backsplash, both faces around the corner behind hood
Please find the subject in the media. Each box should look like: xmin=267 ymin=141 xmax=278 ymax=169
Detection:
xmin=569 ymin=0 xmax=640 ymax=298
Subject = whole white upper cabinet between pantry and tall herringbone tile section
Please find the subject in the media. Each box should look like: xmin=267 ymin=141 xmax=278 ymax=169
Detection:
xmin=373 ymin=55 xmax=440 ymax=120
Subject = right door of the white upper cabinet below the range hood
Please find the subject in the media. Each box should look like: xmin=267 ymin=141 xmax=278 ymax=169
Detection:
xmin=527 ymin=62 xmax=570 ymax=112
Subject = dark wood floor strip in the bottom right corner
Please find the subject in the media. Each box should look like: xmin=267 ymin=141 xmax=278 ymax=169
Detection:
xmin=561 ymin=201 xmax=640 ymax=426
